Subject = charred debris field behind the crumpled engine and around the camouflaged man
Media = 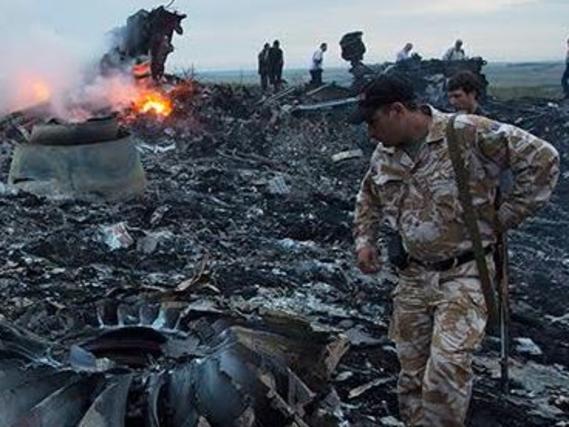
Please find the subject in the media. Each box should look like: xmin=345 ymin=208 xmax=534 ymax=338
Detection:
xmin=0 ymin=79 xmax=569 ymax=427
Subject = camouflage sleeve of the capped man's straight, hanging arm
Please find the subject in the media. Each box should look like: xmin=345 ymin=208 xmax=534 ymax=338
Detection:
xmin=354 ymin=168 xmax=381 ymax=251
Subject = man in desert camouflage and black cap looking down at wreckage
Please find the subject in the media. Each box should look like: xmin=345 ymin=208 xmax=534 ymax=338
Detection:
xmin=354 ymin=77 xmax=559 ymax=426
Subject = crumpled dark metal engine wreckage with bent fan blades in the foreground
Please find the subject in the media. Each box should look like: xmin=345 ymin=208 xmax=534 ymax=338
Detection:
xmin=0 ymin=303 xmax=347 ymax=427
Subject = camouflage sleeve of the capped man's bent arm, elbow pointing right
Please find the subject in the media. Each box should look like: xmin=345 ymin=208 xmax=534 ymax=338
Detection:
xmin=478 ymin=120 xmax=559 ymax=229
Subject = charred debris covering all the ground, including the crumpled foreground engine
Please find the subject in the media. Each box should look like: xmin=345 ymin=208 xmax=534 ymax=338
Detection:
xmin=0 ymin=65 xmax=569 ymax=427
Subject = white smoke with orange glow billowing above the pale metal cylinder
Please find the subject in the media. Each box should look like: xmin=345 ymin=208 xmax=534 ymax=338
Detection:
xmin=0 ymin=13 xmax=136 ymax=121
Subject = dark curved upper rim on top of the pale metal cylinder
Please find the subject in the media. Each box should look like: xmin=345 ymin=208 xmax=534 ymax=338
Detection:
xmin=30 ymin=117 xmax=119 ymax=145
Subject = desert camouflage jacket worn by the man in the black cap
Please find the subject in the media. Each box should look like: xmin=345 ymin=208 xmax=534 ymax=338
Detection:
xmin=354 ymin=109 xmax=559 ymax=262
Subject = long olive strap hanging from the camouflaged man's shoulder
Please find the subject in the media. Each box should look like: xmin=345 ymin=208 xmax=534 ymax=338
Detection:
xmin=446 ymin=115 xmax=498 ymax=326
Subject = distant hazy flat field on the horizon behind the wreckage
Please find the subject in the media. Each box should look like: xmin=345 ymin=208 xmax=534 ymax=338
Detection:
xmin=193 ymin=62 xmax=565 ymax=99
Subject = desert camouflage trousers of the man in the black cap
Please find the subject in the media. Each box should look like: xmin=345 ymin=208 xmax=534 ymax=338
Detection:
xmin=389 ymin=256 xmax=494 ymax=427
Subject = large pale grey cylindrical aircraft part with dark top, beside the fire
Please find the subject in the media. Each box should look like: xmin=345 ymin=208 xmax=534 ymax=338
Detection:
xmin=9 ymin=118 xmax=146 ymax=201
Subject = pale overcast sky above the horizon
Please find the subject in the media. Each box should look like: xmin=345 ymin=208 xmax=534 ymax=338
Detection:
xmin=0 ymin=0 xmax=569 ymax=70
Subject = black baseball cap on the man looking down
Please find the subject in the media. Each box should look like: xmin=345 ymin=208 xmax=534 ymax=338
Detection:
xmin=350 ymin=75 xmax=416 ymax=124
